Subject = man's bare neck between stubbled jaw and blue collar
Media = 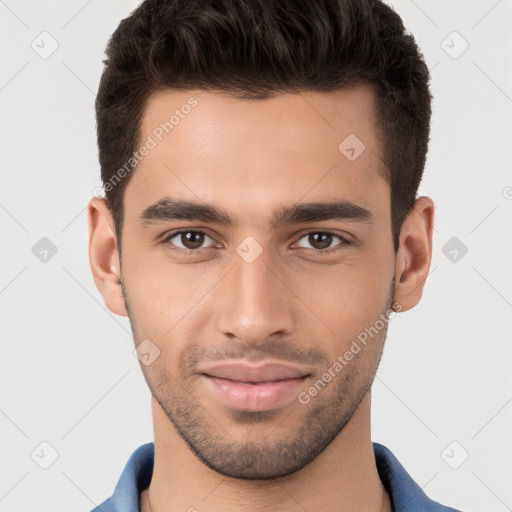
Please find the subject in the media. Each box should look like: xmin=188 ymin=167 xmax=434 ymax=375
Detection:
xmin=140 ymin=392 xmax=392 ymax=512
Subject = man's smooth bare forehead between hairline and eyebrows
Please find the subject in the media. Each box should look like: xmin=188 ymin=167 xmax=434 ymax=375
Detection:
xmin=125 ymin=84 xmax=389 ymax=225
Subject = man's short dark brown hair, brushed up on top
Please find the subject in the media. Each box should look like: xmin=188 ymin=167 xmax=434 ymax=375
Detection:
xmin=95 ymin=0 xmax=432 ymax=252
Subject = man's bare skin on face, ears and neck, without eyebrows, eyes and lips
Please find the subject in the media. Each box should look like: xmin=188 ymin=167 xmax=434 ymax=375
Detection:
xmin=88 ymin=84 xmax=434 ymax=512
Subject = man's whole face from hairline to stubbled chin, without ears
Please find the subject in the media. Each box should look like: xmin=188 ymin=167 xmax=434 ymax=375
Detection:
xmin=94 ymin=85 xmax=402 ymax=479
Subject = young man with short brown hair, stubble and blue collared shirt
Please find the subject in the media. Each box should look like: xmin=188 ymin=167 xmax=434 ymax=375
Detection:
xmin=88 ymin=0 xmax=464 ymax=512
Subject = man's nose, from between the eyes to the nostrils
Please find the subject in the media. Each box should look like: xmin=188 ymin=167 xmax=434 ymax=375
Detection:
xmin=216 ymin=245 xmax=293 ymax=345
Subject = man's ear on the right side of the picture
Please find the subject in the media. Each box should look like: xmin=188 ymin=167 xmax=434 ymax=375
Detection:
xmin=394 ymin=196 xmax=434 ymax=311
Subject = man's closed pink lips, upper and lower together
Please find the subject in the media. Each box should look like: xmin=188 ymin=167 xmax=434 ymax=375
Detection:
xmin=202 ymin=363 xmax=310 ymax=411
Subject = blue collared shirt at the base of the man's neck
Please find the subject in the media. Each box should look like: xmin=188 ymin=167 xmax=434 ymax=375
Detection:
xmin=92 ymin=443 xmax=461 ymax=512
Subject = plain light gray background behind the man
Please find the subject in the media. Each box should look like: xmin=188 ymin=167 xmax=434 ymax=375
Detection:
xmin=0 ymin=0 xmax=512 ymax=512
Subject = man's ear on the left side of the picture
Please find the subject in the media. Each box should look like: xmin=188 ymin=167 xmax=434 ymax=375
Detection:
xmin=87 ymin=197 xmax=128 ymax=316
